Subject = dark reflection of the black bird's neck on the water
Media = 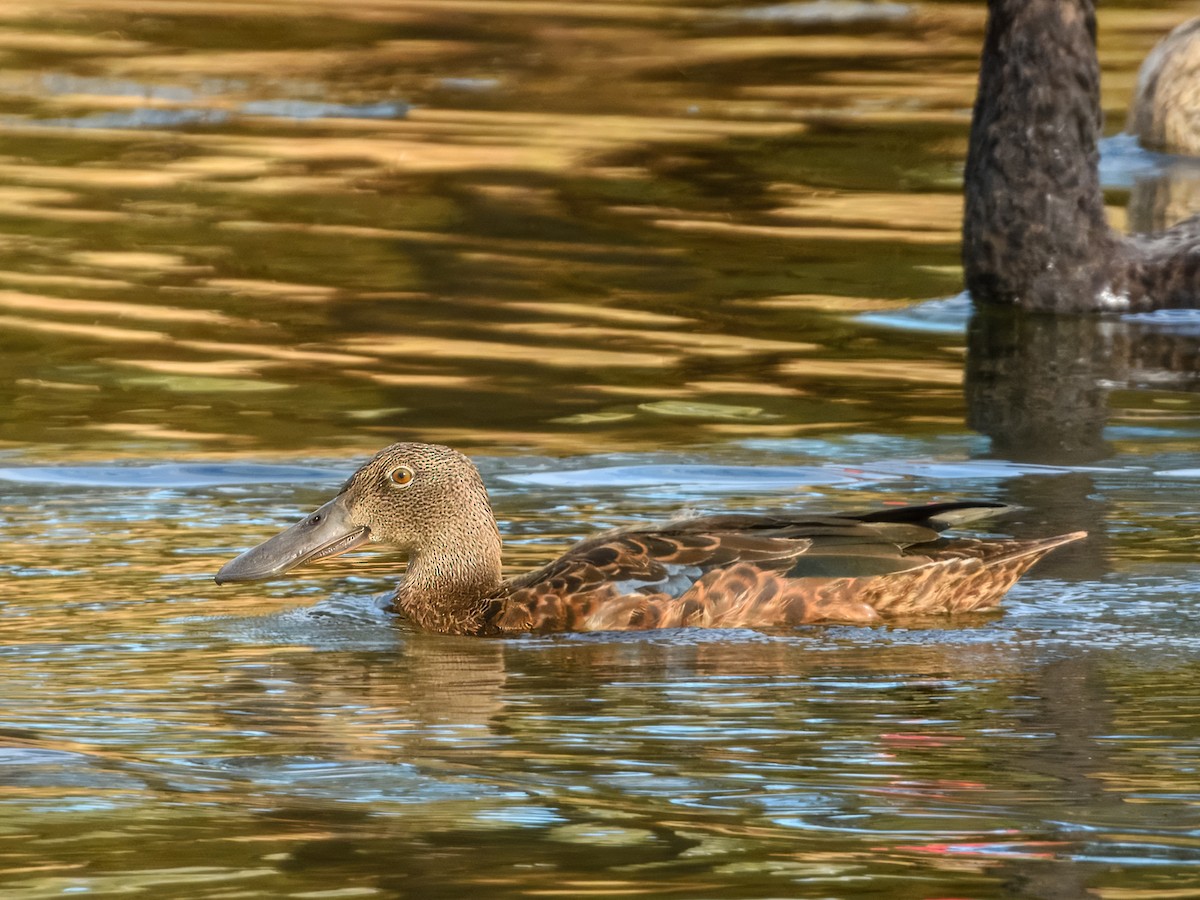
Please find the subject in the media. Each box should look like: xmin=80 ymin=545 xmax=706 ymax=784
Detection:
xmin=965 ymin=308 xmax=1200 ymax=577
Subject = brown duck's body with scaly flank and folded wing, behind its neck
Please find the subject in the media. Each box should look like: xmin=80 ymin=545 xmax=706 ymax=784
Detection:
xmin=490 ymin=503 xmax=1065 ymax=631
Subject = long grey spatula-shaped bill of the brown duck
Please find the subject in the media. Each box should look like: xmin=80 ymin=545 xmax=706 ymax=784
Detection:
xmin=216 ymin=493 xmax=371 ymax=584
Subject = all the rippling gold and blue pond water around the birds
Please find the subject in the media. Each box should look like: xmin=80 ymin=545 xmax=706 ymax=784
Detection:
xmin=0 ymin=0 xmax=1200 ymax=900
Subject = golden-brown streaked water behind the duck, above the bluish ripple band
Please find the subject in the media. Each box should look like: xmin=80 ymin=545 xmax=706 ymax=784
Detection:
xmin=0 ymin=0 xmax=1190 ymax=455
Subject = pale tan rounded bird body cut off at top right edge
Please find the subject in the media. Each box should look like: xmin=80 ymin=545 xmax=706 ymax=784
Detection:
xmin=1126 ymin=18 xmax=1200 ymax=156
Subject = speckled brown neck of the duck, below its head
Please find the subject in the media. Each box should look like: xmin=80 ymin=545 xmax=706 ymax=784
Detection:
xmin=396 ymin=518 xmax=500 ymax=635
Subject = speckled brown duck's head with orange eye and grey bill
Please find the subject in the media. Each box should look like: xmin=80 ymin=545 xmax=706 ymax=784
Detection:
xmin=216 ymin=443 xmax=500 ymax=587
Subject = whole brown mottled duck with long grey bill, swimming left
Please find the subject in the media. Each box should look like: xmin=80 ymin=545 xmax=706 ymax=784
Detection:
xmin=216 ymin=443 xmax=1085 ymax=635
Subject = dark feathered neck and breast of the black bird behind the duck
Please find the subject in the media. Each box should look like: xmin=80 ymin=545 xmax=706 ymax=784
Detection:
xmin=962 ymin=0 xmax=1200 ymax=312
